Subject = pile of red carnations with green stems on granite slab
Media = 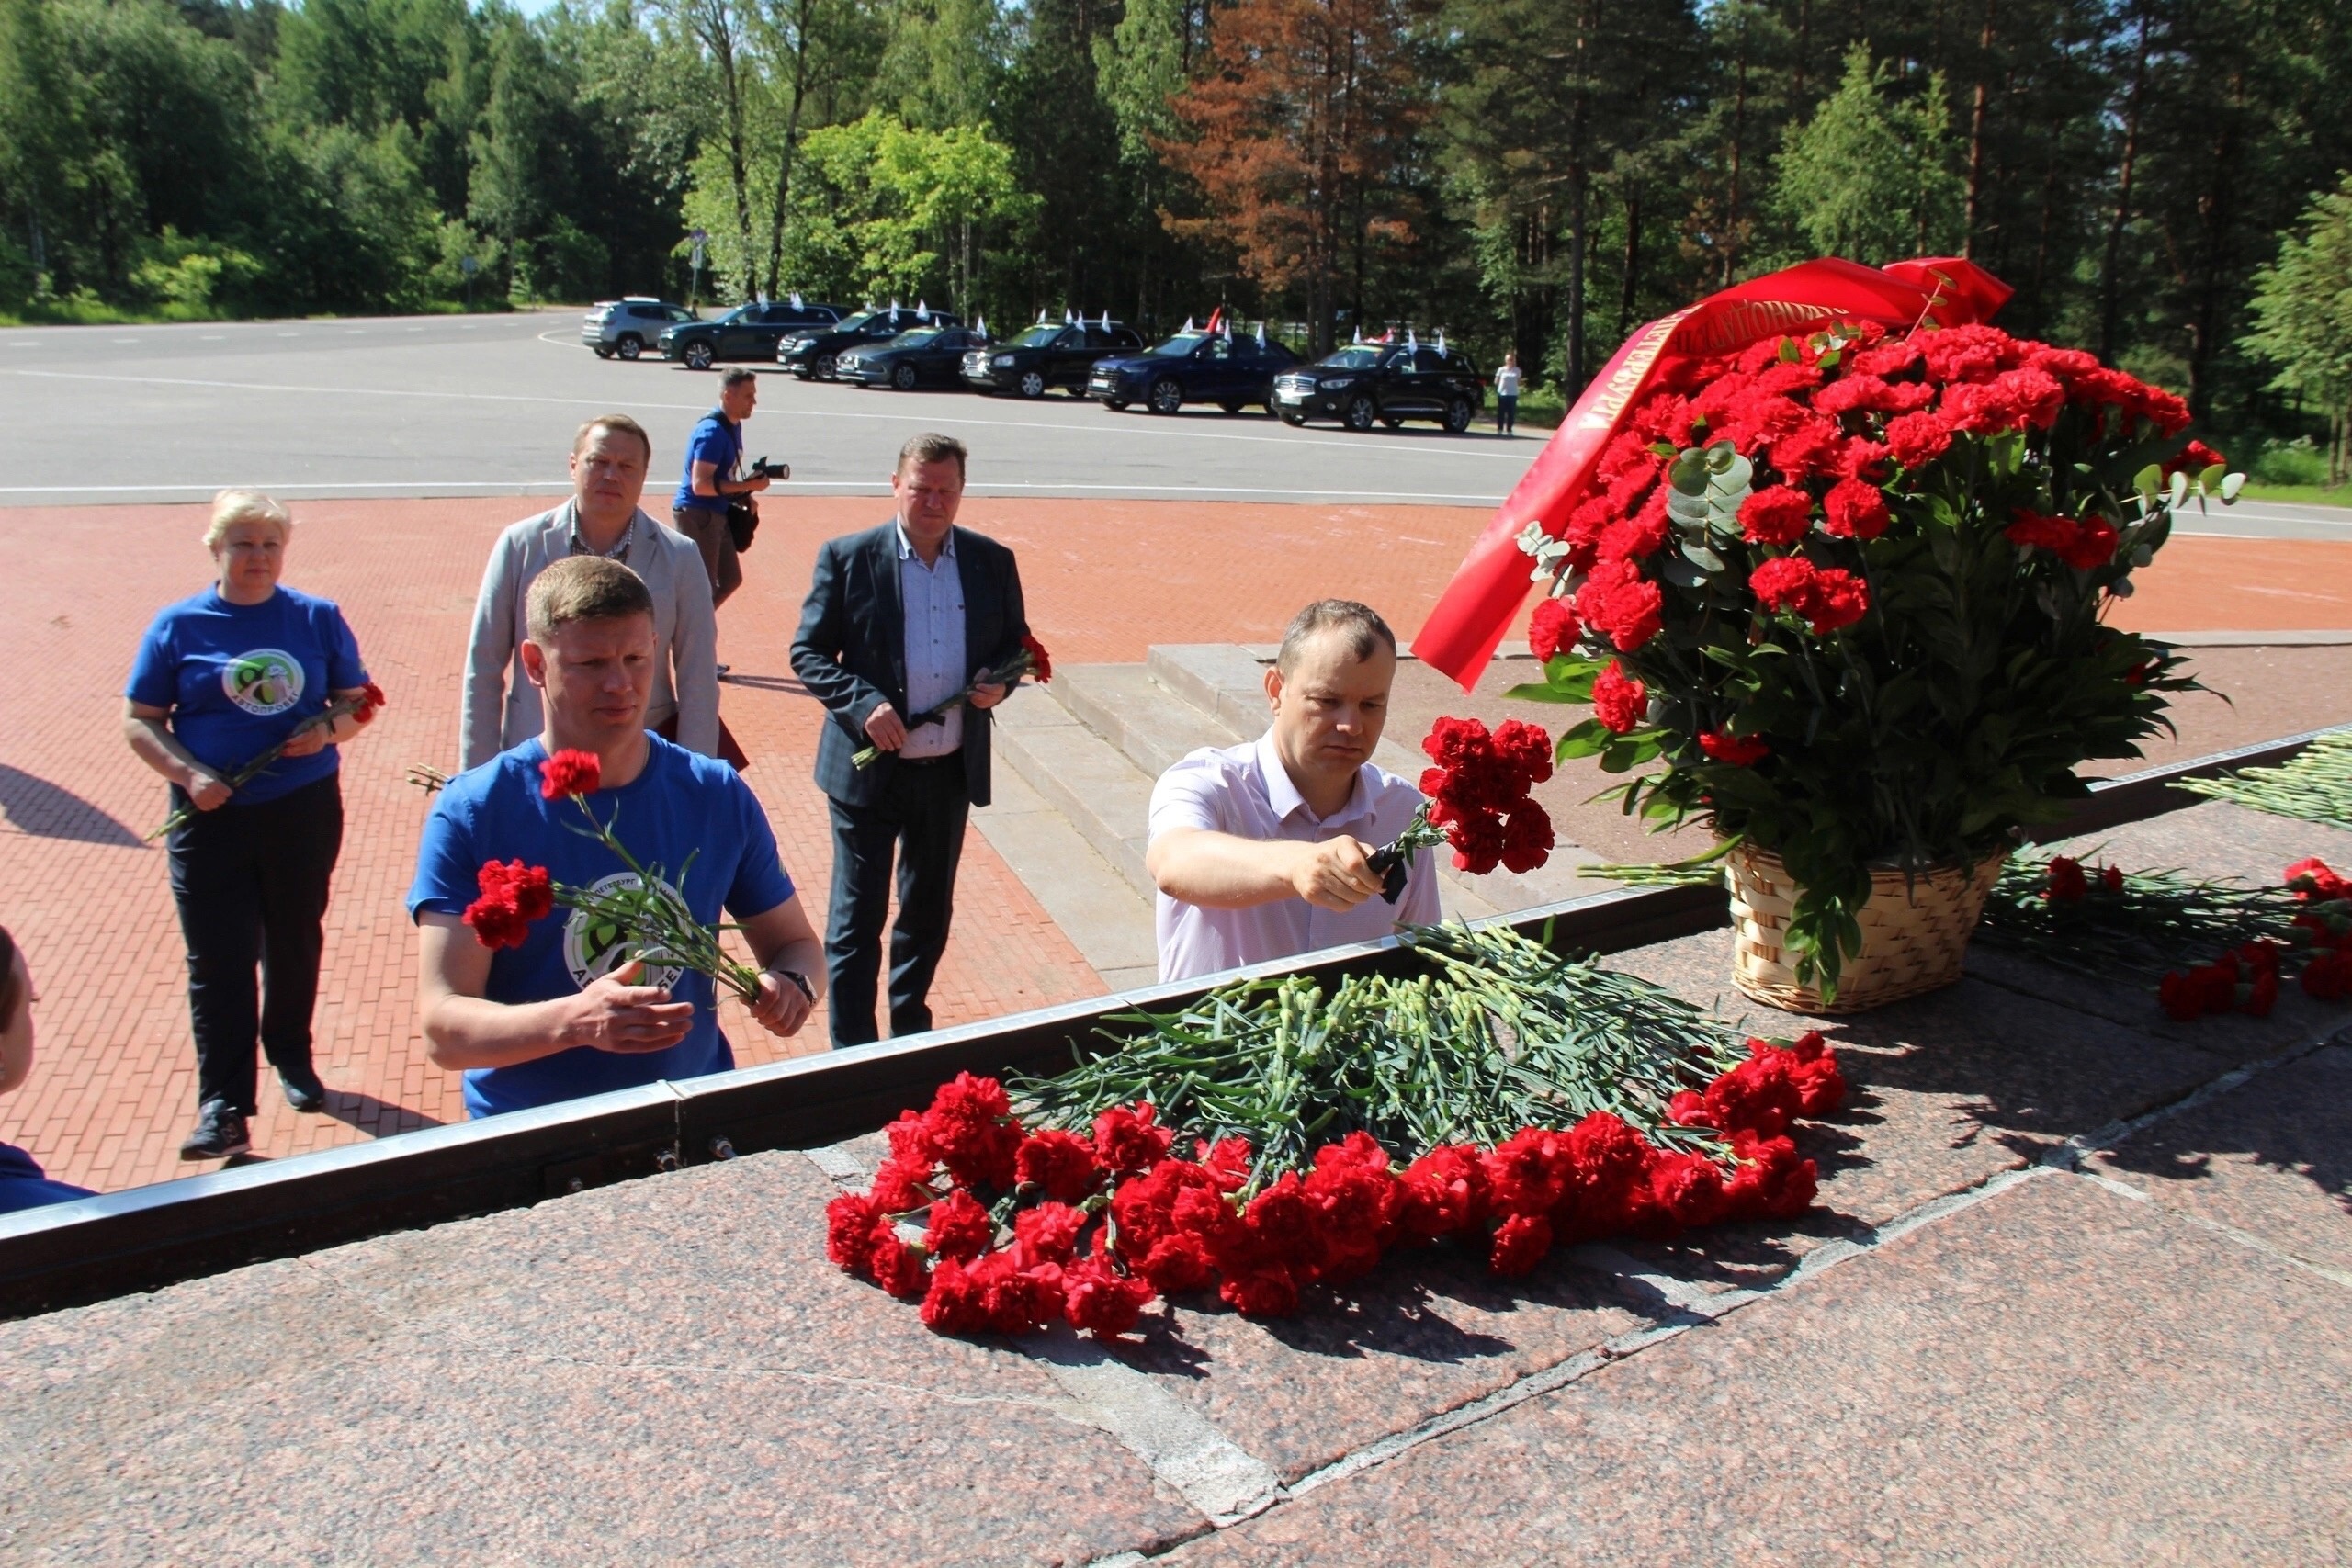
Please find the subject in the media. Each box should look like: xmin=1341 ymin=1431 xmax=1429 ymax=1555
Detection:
xmin=828 ymin=926 xmax=1844 ymax=1337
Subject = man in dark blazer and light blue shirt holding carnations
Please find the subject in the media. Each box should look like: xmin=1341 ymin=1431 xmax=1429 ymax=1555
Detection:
xmin=793 ymin=434 xmax=1028 ymax=1046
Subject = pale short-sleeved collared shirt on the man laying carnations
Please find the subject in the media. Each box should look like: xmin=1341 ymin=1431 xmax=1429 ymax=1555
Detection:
xmin=1150 ymin=731 xmax=1442 ymax=980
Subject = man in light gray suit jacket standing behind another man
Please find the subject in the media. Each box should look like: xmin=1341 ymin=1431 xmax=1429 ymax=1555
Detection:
xmin=458 ymin=413 xmax=719 ymax=771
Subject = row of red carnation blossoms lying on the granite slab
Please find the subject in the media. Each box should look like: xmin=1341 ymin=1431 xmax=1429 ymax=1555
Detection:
xmin=826 ymin=1034 xmax=1847 ymax=1337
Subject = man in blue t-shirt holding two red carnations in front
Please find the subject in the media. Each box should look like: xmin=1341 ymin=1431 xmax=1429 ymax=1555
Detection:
xmin=409 ymin=555 xmax=826 ymax=1117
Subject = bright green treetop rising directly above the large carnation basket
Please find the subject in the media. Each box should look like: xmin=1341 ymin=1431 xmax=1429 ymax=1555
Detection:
xmin=1773 ymin=45 xmax=1966 ymax=264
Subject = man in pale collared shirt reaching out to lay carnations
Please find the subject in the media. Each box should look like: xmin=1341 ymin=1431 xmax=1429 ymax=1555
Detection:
xmin=1143 ymin=600 xmax=1440 ymax=980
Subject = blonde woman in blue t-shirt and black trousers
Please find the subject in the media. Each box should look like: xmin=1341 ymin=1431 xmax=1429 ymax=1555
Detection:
xmin=122 ymin=489 xmax=367 ymax=1159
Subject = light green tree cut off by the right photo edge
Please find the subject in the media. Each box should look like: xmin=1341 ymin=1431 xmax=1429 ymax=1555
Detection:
xmin=2244 ymin=174 xmax=2352 ymax=484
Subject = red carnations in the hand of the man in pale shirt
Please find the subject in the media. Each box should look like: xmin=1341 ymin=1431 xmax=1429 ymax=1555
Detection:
xmin=1369 ymin=719 xmax=1553 ymax=903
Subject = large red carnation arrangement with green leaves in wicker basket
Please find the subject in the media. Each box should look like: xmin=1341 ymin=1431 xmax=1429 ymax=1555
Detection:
xmin=1512 ymin=322 xmax=2242 ymax=995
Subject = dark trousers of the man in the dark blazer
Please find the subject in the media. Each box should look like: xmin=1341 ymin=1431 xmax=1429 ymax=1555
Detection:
xmin=826 ymin=752 xmax=971 ymax=1046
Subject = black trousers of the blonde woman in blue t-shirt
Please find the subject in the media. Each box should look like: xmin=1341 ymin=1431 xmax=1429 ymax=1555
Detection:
xmin=169 ymin=776 xmax=344 ymax=1117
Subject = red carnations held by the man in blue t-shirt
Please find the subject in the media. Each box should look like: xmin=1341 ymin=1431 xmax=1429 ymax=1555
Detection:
xmin=463 ymin=750 xmax=760 ymax=1004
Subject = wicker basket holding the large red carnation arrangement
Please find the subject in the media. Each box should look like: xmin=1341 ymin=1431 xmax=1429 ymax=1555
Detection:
xmin=1724 ymin=844 xmax=2002 ymax=1013
